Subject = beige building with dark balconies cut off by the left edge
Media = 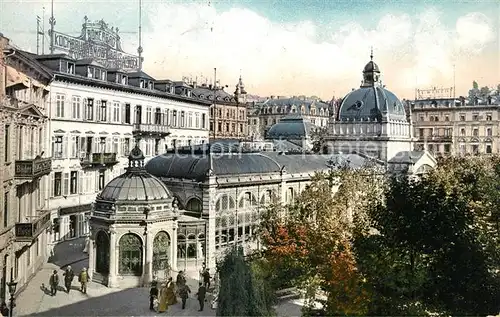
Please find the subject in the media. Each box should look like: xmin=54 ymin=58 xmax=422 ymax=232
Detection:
xmin=0 ymin=34 xmax=51 ymax=302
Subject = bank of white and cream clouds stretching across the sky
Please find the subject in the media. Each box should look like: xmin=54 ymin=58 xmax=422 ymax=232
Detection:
xmin=1 ymin=0 xmax=498 ymax=98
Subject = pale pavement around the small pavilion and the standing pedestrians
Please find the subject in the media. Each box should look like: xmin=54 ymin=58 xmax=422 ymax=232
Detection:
xmin=14 ymin=240 xmax=300 ymax=316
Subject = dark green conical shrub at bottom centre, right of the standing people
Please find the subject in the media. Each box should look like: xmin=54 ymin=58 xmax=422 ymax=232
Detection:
xmin=217 ymin=247 xmax=274 ymax=316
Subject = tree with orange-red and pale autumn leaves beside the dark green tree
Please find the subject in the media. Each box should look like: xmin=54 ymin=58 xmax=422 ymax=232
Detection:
xmin=261 ymin=169 xmax=380 ymax=315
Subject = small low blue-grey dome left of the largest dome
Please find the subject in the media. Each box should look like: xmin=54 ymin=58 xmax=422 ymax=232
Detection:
xmin=266 ymin=114 xmax=314 ymax=140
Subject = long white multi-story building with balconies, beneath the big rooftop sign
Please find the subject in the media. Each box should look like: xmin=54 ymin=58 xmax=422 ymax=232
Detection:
xmin=29 ymin=54 xmax=210 ymax=243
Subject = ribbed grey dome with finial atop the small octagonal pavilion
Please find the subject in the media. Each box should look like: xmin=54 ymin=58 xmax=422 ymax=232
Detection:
xmin=97 ymin=146 xmax=172 ymax=201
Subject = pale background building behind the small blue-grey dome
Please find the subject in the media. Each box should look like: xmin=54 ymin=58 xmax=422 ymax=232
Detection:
xmin=248 ymin=96 xmax=331 ymax=140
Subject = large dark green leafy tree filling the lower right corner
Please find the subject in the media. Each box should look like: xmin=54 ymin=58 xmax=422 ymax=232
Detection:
xmin=355 ymin=157 xmax=500 ymax=315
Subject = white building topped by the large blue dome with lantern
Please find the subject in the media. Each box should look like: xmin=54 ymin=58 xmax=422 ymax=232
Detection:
xmin=325 ymin=52 xmax=436 ymax=172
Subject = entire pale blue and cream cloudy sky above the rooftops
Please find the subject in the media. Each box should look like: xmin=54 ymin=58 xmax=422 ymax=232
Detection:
xmin=0 ymin=0 xmax=500 ymax=100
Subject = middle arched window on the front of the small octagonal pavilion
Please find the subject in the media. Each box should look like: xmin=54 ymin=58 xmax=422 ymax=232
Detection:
xmin=119 ymin=233 xmax=142 ymax=276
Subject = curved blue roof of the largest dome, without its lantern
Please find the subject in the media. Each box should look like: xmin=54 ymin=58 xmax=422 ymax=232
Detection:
xmin=338 ymin=86 xmax=406 ymax=121
